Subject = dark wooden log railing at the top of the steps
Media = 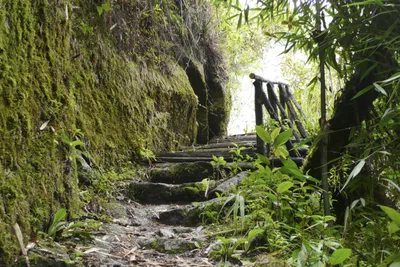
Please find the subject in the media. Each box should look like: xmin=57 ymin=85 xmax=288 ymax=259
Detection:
xmin=250 ymin=73 xmax=308 ymax=157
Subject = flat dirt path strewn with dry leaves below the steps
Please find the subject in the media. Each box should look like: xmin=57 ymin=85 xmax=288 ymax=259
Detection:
xmin=84 ymin=200 xmax=215 ymax=266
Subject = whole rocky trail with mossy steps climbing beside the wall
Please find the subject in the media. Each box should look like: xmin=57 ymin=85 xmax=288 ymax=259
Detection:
xmin=23 ymin=134 xmax=304 ymax=267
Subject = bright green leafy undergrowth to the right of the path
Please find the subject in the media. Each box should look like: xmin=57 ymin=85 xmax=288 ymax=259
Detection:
xmin=208 ymin=127 xmax=400 ymax=267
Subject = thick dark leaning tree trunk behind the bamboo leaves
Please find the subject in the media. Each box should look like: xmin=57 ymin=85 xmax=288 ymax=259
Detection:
xmin=303 ymin=49 xmax=398 ymax=223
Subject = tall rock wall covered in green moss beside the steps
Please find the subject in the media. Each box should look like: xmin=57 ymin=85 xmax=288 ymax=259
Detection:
xmin=0 ymin=0 xmax=230 ymax=265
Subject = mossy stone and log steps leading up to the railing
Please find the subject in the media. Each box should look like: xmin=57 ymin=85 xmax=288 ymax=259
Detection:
xmin=126 ymin=134 xmax=305 ymax=226
